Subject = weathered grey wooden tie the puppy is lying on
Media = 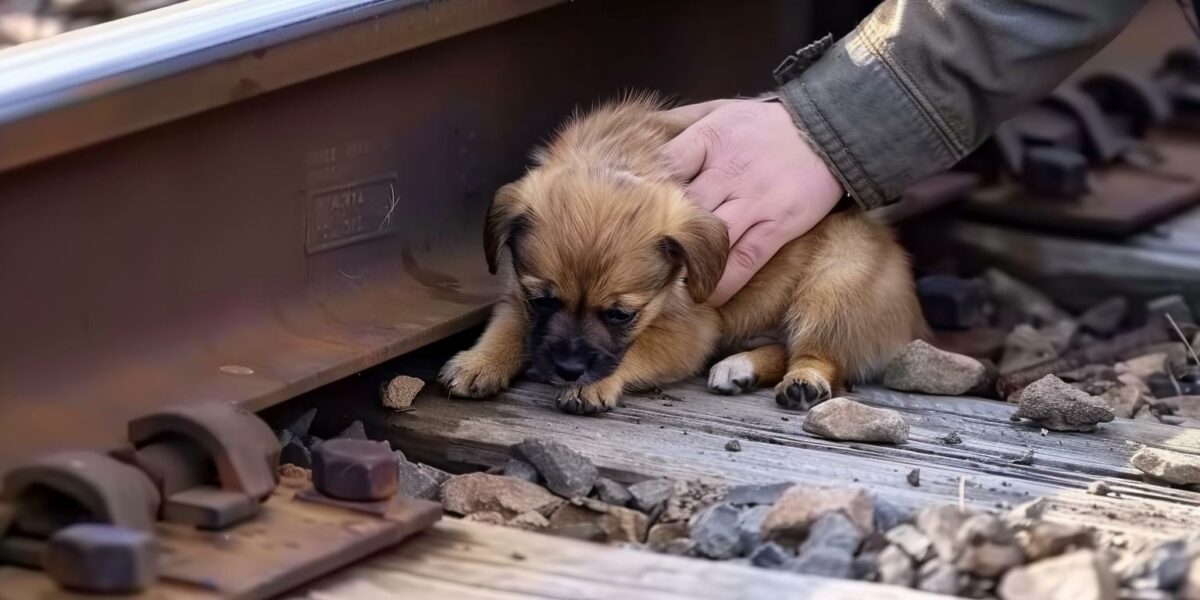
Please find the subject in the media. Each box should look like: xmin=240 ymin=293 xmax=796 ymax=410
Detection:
xmin=343 ymin=365 xmax=1200 ymax=540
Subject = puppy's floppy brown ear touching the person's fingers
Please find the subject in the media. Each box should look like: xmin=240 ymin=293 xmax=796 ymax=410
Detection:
xmin=665 ymin=212 xmax=730 ymax=304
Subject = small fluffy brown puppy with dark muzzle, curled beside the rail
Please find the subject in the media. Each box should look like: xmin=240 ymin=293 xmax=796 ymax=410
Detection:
xmin=440 ymin=97 xmax=925 ymax=414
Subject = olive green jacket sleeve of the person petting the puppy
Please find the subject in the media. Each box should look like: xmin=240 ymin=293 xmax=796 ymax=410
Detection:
xmin=775 ymin=0 xmax=1147 ymax=209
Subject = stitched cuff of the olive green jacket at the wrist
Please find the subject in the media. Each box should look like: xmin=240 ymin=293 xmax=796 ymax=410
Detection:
xmin=775 ymin=29 xmax=965 ymax=210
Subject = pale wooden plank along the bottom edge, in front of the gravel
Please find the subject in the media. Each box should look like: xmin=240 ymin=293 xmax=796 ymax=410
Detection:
xmin=292 ymin=520 xmax=942 ymax=600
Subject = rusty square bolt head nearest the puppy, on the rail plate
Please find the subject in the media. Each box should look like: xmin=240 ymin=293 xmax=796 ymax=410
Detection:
xmin=312 ymin=439 xmax=400 ymax=502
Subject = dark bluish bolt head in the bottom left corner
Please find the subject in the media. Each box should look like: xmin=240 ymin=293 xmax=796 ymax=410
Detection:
xmin=44 ymin=523 xmax=158 ymax=594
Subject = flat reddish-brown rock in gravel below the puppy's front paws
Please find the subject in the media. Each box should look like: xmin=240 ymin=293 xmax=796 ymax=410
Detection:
xmin=442 ymin=473 xmax=563 ymax=517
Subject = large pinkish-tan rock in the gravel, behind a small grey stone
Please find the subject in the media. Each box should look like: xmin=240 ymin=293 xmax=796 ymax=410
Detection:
xmin=762 ymin=485 xmax=875 ymax=545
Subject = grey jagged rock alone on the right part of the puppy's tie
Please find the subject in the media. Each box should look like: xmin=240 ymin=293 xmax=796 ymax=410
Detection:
xmin=1014 ymin=374 xmax=1114 ymax=432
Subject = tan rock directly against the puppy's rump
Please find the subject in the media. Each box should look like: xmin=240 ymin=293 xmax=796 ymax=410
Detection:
xmin=883 ymin=340 xmax=988 ymax=396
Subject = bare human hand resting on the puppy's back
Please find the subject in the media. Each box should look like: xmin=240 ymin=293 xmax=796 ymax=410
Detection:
xmin=665 ymin=100 xmax=842 ymax=306
